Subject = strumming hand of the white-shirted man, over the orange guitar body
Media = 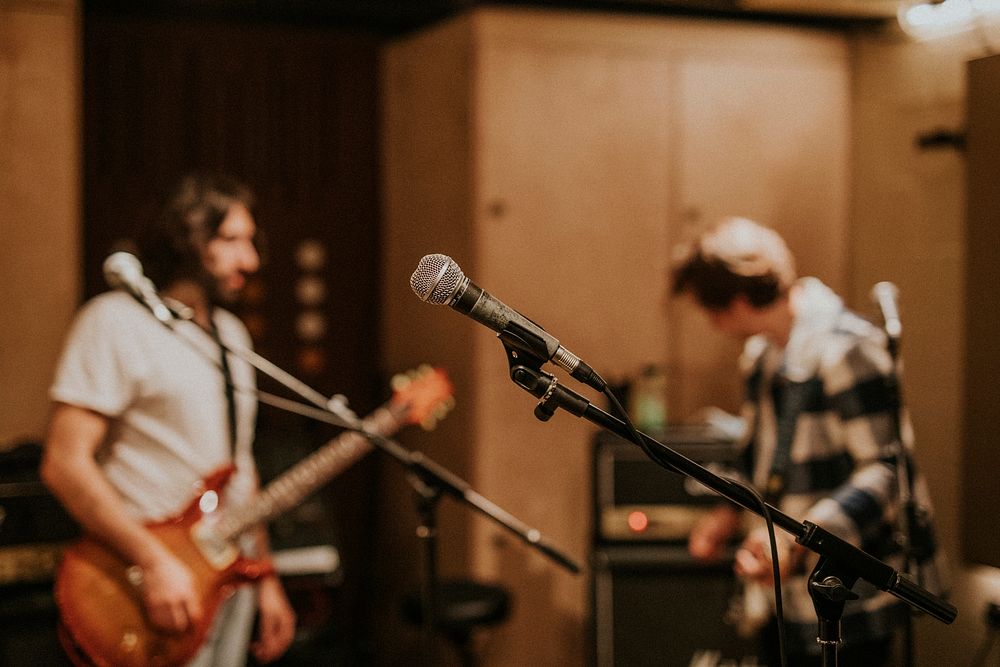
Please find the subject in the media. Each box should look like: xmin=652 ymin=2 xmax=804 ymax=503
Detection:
xmin=134 ymin=553 xmax=204 ymax=632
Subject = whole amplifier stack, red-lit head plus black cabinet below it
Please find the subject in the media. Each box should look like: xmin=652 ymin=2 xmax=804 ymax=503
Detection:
xmin=591 ymin=427 xmax=756 ymax=667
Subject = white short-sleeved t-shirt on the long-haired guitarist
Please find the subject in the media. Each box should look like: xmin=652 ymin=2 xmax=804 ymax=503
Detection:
xmin=50 ymin=292 xmax=257 ymax=520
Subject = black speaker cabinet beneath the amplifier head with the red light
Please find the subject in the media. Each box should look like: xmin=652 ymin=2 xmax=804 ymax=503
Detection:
xmin=592 ymin=544 xmax=755 ymax=667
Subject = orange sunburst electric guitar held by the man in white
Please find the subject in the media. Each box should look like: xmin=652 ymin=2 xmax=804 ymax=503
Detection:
xmin=55 ymin=366 xmax=454 ymax=667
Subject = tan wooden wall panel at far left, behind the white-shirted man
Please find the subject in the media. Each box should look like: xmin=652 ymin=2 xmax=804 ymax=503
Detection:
xmin=0 ymin=0 xmax=80 ymax=448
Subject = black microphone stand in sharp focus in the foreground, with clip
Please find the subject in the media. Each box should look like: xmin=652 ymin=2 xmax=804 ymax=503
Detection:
xmin=498 ymin=328 xmax=958 ymax=667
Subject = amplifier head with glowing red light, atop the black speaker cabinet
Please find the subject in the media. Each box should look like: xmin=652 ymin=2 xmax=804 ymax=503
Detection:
xmin=594 ymin=426 xmax=737 ymax=542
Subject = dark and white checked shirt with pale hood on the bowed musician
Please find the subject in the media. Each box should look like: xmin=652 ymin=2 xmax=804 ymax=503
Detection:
xmin=740 ymin=278 xmax=939 ymax=653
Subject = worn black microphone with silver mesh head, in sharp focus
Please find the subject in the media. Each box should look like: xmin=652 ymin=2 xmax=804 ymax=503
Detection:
xmin=410 ymin=254 xmax=607 ymax=391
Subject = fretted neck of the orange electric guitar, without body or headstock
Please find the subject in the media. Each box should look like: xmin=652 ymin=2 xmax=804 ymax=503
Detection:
xmin=216 ymin=402 xmax=407 ymax=540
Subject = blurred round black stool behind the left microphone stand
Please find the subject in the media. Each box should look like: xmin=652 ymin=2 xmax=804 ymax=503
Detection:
xmin=403 ymin=579 xmax=510 ymax=667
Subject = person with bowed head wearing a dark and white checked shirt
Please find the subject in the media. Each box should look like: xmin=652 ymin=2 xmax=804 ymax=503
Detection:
xmin=672 ymin=218 xmax=940 ymax=665
